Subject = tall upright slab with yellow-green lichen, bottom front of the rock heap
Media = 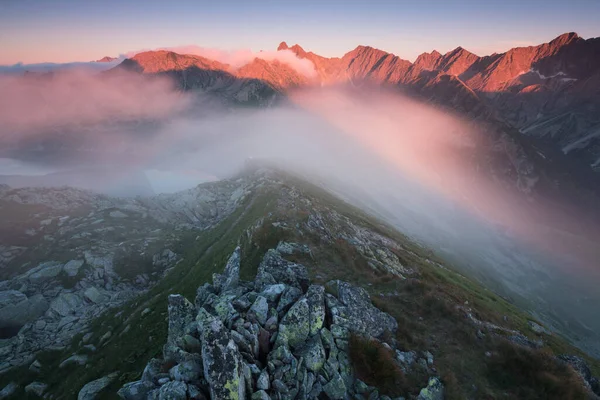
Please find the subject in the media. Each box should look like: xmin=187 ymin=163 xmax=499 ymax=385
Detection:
xmin=202 ymin=318 xmax=246 ymax=400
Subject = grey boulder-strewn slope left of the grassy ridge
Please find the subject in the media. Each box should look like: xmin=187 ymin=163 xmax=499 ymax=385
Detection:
xmin=0 ymin=173 xmax=260 ymax=373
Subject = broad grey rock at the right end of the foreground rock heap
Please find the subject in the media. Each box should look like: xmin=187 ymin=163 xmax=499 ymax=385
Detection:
xmin=327 ymin=280 xmax=398 ymax=337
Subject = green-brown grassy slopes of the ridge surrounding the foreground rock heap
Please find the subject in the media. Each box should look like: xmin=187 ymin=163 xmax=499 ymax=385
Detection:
xmin=0 ymin=173 xmax=600 ymax=399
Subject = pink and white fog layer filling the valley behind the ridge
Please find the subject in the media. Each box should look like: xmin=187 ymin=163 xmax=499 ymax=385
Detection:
xmin=0 ymin=75 xmax=600 ymax=353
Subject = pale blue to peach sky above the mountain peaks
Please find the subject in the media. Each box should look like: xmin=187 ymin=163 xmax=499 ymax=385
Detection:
xmin=0 ymin=0 xmax=600 ymax=65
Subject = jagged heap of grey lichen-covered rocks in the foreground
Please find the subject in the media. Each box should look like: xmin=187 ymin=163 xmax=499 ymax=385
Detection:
xmin=118 ymin=244 xmax=443 ymax=399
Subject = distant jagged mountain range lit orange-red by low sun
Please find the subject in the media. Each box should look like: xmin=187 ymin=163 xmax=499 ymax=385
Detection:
xmin=117 ymin=32 xmax=600 ymax=180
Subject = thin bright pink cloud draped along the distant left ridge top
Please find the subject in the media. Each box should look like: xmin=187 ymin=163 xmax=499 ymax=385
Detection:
xmin=123 ymin=45 xmax=316 ymax=78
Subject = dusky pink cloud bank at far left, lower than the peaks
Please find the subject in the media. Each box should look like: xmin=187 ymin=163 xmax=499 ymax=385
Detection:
xmin=0 ymin=69 xmax=189 ymax=138
